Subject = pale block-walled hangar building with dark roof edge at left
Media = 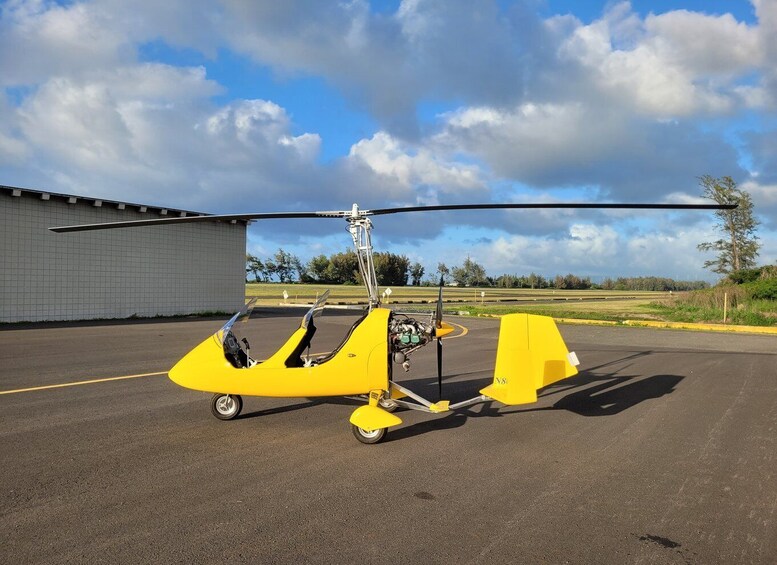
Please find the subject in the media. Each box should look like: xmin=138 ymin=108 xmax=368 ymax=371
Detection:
xmin=0 ymin=185 xmax=247 ymax=322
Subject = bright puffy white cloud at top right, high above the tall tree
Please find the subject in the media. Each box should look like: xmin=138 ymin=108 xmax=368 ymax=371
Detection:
xmin=559 ymin=3 xmax=764 ymax=117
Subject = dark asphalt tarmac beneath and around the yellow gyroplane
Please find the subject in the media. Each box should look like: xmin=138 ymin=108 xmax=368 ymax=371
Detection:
xmin=0 ymin=310 xmax=777 ymax=564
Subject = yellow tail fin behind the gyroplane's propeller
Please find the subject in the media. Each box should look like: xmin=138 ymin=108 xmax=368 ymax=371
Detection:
xmin=480 ymin=314 xmax=578 ymax=404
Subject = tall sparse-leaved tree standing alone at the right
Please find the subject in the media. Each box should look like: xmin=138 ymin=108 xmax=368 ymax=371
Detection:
xmin=697 ymin=175 xmax=761 ymax=275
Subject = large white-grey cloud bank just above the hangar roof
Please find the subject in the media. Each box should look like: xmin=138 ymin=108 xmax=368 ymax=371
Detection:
xmin=11 ymin=64 xmax=328 ymax=210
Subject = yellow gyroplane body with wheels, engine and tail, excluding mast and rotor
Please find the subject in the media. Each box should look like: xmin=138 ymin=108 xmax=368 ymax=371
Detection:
xmin=169 ymin=286 xmax=577 ymax=443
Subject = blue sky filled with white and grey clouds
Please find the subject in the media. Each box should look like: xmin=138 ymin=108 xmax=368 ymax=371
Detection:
xmin=0 ymin=0 xmax=777 ymax=282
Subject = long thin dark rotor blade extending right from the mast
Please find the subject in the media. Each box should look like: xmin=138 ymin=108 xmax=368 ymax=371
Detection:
xmin=368 ymin=202 xmax=737 ymax=216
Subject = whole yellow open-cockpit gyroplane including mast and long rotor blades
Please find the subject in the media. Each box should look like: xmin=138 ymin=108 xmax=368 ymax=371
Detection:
xmin=50 ymin=203 xmax=733 ymax=444
